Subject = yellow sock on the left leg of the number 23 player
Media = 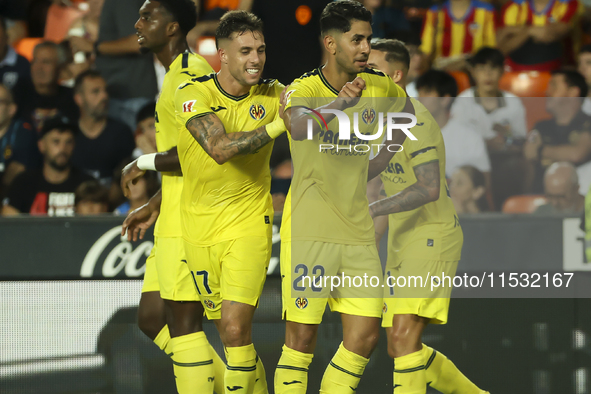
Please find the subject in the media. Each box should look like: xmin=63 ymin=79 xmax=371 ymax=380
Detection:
xmin=275 ymin=345 xmax=314 ymax=394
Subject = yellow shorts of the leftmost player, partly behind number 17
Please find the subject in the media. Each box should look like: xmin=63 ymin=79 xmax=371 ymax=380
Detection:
xmin=151 ymin=237 xmax=199 ymax=301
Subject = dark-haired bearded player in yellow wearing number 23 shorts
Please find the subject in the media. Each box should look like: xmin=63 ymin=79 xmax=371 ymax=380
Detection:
xmin=275 ymin=0 xmax=413 ymax=394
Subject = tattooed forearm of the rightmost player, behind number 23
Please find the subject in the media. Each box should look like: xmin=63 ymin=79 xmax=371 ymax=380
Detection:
xmin=369 ymin=160 xmax=440 ymax=217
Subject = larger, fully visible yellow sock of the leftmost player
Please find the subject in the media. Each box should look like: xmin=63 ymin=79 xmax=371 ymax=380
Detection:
xmin=170 ymin=331 xmax=215 ymax=394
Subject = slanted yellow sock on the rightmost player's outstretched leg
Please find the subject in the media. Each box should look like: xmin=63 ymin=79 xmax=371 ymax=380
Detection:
xmin=423 ymin=345 xmax=482 ymax=394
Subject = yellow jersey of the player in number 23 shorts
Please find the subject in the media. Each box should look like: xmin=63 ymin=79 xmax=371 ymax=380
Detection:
xmin=281 ymin=68 xmax=406 ymax=245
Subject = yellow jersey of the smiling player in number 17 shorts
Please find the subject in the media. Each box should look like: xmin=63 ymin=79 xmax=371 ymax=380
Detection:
xmin=175 ymin=73 xmax=284 ymax=246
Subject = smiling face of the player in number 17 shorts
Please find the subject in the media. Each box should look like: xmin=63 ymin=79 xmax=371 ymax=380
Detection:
xmin=220 ymin=31 xmax=267 ymax=86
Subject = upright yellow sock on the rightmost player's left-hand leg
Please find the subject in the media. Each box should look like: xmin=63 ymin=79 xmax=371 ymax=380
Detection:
xmin=394 ymin=350 xmax=427 ymax=394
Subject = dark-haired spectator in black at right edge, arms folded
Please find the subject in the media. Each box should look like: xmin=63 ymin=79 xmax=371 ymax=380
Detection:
xmin=523 ymin=70 xmax=591 ymax=193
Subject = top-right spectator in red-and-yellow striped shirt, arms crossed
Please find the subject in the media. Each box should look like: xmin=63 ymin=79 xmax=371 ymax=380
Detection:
xmin=498 ymin=0 xmax=583 ymax=71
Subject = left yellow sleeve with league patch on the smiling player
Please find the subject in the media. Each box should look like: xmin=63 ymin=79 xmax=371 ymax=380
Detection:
xmin=174 ymin=82 xmax=213 ymax=126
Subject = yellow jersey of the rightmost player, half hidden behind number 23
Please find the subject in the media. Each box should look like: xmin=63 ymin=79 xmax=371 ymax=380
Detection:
xmin=380 ymin=99 xmax=464 ymax=261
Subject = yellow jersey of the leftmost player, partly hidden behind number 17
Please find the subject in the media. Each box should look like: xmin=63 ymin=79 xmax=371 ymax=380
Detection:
xmin=154 ymin=52 xmax=212 ymax=237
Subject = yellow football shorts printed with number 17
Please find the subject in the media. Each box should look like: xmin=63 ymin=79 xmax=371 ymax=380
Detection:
xmin=185 ymin=237 xmax=272 ymax=320
